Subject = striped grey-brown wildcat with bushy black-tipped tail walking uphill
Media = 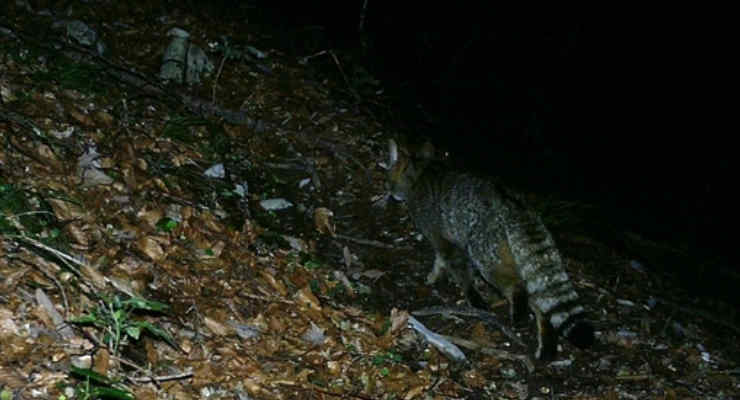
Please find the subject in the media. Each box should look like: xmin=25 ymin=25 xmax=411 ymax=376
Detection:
xmin=388 ymin=141 xmax=593 ymax=360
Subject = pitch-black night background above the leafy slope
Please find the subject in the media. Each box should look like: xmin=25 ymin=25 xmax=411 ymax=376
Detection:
xmin=227 ymin=0 xmax=738 ymax=297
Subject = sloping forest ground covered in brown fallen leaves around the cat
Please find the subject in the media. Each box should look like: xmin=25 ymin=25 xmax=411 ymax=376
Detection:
xmin=0 ymin=2 xmax=740 ymax=399
